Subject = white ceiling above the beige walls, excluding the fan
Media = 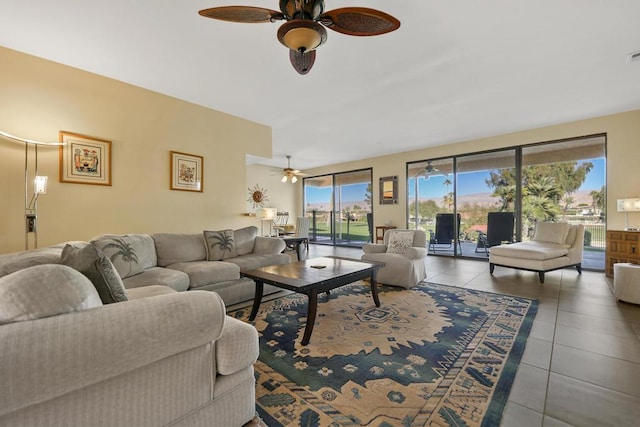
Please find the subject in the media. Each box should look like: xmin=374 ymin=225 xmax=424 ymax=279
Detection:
xmin=0 ymin=0 xmax=640 ymax=169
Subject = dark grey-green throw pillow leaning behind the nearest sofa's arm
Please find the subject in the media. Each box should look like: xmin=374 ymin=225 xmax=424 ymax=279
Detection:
xmin=61 ymin=242 xmax=128 ymax=304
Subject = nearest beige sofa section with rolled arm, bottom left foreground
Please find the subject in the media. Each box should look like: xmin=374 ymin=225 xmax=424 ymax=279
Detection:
xmin=0 ymin=264 xmax=259 ymax=427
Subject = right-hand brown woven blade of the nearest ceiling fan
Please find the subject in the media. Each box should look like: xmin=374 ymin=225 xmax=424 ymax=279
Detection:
xmin=318 ymin=7 xmax=400 ymax=36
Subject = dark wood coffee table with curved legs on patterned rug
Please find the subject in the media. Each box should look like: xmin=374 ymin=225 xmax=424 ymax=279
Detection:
xmin=241 ymin=257 xmax=384 ymax=345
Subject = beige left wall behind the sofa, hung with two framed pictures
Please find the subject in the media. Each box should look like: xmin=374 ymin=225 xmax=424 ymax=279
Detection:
xmin=0 ymin=47 xmax=271 ymax=253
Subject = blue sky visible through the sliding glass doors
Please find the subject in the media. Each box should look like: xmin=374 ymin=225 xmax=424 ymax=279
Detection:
xmin=305 ymin=158 xmax=605 ymax=204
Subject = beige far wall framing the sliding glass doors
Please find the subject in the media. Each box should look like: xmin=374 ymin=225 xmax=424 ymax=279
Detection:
xmin=298 ymin=110 xmax=640 ymax=229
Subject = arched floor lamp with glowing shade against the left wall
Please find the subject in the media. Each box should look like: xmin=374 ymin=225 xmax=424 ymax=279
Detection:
xmin=0 ymin=131 xmax=64 ymax=250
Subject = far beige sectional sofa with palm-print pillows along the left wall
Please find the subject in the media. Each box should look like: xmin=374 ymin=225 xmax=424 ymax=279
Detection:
xmin=0 ymin=226 xmax=291 ymax=306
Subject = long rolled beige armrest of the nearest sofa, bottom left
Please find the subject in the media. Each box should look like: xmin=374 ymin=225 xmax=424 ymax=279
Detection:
xmin=0 ymin=291 xmax=226 ymax=414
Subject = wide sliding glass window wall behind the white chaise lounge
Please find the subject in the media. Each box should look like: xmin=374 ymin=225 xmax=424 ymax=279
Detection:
xmin=407 ymin=135 xmax=606 ymax=269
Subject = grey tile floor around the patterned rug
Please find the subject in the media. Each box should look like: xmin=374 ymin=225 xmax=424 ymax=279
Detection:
xmin=307 ymin=245 xmax=640 ymax=427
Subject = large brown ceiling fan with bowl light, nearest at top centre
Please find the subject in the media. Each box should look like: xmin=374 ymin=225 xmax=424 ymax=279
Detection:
xmin=198 ymin=0 xmax=400 ymax=74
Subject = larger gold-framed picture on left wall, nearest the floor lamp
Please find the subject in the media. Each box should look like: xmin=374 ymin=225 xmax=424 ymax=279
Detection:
xmin=59 ymin=131 xmax=111 ymax=185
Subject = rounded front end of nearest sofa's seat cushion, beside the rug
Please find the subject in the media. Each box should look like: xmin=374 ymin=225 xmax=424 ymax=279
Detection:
xmin=216 ymin=316 xmax=260 ymax=375
